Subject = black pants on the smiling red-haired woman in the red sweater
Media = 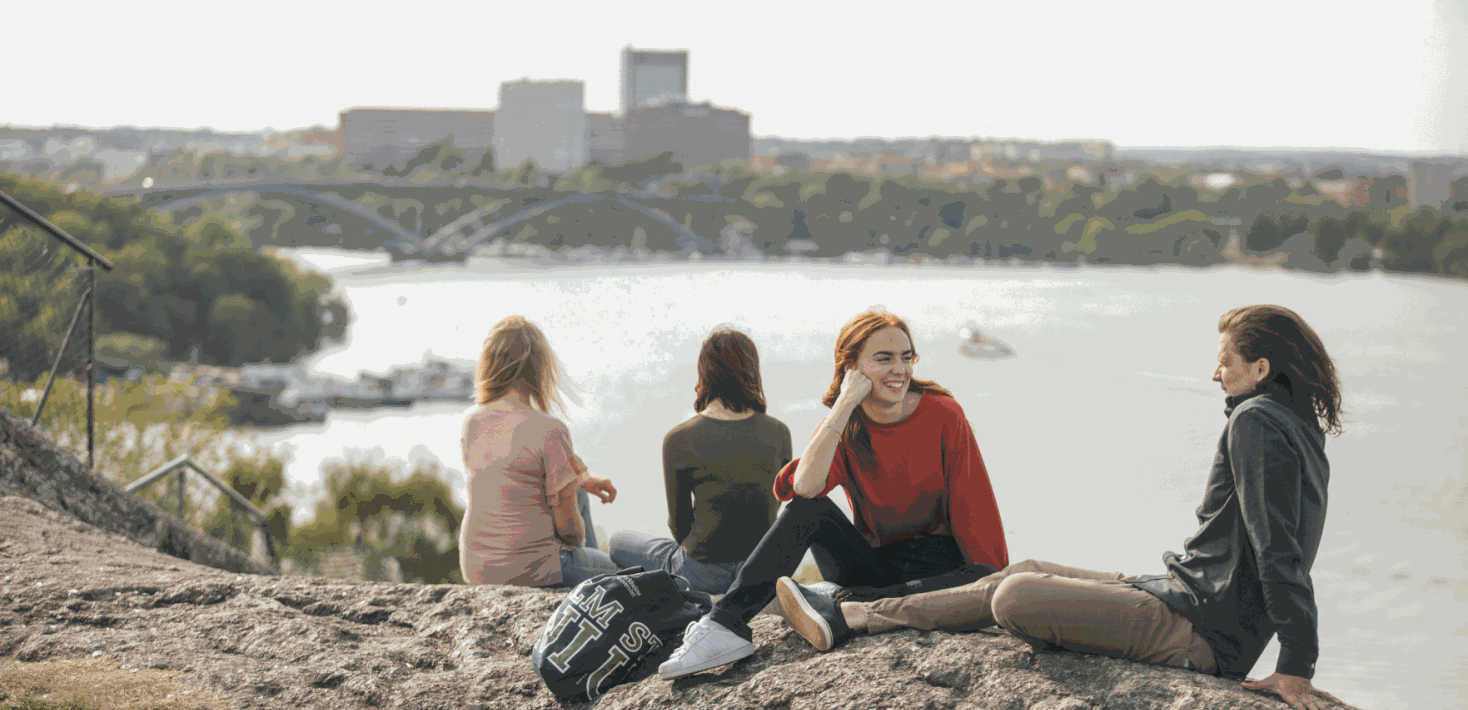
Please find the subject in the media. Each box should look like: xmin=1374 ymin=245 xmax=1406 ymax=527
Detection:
xmin=709 ymin=496 xmax=994 ymax=638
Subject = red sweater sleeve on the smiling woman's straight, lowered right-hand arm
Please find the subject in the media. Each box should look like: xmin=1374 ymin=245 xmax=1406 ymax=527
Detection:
xmin=942 ymin=402 xmax=1009 ymax=569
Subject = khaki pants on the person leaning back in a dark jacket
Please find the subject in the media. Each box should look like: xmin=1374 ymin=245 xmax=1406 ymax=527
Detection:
xmin=841 ymin=560 xmax=1218 ymax=673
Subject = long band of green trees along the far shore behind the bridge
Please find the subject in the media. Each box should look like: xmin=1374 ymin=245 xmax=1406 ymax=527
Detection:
xmin=140 ymin=136 xmax=1468 ymax=276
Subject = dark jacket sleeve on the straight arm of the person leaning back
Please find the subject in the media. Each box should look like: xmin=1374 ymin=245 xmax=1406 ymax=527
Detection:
xmin=1229 ymin=408 xmax=1320 ymax=678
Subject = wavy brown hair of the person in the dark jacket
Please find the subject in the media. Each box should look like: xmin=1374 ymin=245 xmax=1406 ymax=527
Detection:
xmin=1218 ymin=305 xmax=1343 ymax=436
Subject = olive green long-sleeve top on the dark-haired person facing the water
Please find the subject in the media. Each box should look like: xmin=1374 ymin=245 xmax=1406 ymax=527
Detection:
xmin=662 ymin=412 xmax=793 ymax=563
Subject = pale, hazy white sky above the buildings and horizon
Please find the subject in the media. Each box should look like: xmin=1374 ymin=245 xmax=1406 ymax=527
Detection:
xmin=11 ymin=0 xmax=1468 ymax=154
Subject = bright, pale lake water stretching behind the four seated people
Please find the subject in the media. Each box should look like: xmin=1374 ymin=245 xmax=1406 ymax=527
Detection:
xmin=260 ymin=249 xmax=1468 ymax=709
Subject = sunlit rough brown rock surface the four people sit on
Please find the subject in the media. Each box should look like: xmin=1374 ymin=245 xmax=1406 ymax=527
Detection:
xmin=0 ymin=496 xmax=1356 ymax=710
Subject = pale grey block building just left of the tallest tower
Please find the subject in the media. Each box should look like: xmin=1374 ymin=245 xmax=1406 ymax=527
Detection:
xmin=495 ymin=79 xmax=590 ymax=173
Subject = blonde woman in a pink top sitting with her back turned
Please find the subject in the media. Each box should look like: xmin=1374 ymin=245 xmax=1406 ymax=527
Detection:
xmin=459 ymin=315 xmax=617 ymax=587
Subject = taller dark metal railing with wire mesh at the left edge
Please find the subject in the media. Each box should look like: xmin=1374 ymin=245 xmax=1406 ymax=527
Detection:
xmin=0 ymin=192 xmax=113 ymax=468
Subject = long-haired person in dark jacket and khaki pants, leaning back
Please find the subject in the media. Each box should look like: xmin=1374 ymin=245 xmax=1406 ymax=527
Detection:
xmin=781 ymin=305 xmax=1340 ymax=710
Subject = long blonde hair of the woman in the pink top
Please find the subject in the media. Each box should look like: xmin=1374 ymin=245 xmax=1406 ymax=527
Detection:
xmin=474 ymin=315 xmax=565 ymax=414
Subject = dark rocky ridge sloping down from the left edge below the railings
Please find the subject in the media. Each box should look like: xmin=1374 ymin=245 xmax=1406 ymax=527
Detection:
xmin=0 ymin=406 xmax=275 ymax=574
